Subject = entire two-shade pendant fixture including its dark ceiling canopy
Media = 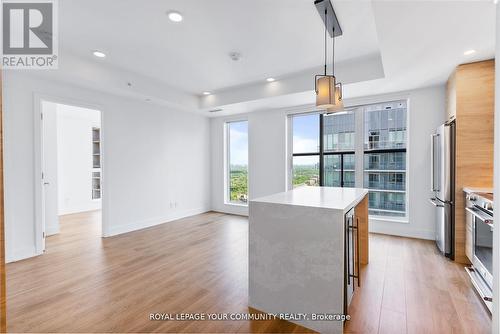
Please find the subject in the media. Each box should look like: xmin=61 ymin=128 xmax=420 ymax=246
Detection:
xmin=314 ymin=0 xmax=344 ymax=113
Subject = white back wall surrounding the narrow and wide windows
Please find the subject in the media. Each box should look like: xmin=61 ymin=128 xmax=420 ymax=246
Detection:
xmin=211 ymin=85 xmax=445 ymax=239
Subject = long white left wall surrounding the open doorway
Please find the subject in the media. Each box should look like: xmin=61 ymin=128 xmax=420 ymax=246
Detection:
xmin=3 ymin=71 xmax=210 ymax=262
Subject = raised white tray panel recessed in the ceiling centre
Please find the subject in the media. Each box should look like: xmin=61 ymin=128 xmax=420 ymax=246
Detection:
xmin=59 ymin=0 xmax=378 ymax=94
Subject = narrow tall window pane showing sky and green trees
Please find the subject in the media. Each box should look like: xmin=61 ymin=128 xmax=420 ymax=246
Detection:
xmin=226 ymin=121 xmax=248 ymax=205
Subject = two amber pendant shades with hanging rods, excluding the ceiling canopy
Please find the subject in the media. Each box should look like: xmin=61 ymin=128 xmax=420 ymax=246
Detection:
xmin=314 ymin=7 xmax=344 ymax=113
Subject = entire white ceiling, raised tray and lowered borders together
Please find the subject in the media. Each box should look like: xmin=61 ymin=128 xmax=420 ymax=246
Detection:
xmin=46 ymin=0 xmax=495 ymax=116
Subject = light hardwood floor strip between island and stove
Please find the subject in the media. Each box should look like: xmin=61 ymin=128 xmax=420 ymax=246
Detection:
xmin=346 ymin=234 xmax=491 ymax=334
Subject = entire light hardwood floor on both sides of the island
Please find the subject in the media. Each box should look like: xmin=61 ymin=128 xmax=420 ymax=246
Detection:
xmin=7 ymin=212 xmax=491 ymax=334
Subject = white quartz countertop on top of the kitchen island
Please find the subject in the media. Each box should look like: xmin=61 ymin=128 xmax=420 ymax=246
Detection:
xmin=250 ymin=186 xmax=368 ymax=210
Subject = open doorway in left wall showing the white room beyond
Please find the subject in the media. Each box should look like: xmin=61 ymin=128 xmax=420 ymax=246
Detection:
xmin=40 ymin=100 xmax=102 ymax=251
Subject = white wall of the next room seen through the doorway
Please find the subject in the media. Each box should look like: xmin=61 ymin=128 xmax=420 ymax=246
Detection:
xmin=57 ymin=104 xmax=101 ymax=215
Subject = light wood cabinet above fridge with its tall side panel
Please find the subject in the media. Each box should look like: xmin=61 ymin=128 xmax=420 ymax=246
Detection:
xmin=446 ymin=60 xmax=495 ymax=263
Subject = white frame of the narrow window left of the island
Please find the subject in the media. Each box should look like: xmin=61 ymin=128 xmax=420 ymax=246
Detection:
xmin=223 ymin=118 xmax=250 ymax=208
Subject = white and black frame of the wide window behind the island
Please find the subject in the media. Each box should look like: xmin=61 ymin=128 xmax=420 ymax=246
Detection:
xmin=286 ymin=99 xmax=411 ymax=224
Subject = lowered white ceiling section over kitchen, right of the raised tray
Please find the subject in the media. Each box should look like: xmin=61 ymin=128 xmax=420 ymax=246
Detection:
xmin=348 ymin=0 xmax=496 ymax=97
